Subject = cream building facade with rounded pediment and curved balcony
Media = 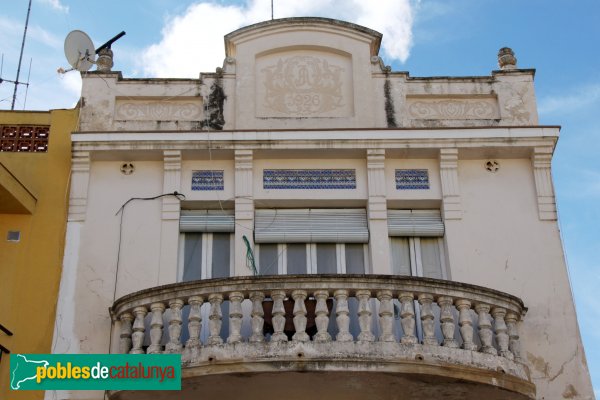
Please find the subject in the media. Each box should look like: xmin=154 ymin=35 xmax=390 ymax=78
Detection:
xmin=47 ymin=18 xmax=593 ymax=399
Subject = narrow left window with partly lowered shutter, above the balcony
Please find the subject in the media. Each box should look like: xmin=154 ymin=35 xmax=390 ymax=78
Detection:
xmin=179 ymin=210 xmax=235 ymax=282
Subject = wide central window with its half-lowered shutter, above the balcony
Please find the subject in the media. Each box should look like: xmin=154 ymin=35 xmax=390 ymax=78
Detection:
xmin=254 ymin=208 xmax=369 ymax=275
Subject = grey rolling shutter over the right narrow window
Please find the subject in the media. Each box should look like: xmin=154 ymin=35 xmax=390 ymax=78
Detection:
xmin=388 ymin=210 xmax=444 ymax=237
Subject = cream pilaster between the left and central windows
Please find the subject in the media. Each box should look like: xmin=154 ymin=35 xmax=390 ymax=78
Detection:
xmin=234 ymin=150 xmax=254 ymax=276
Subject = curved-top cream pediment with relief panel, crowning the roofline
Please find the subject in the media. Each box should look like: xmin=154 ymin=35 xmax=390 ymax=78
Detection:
xmin=225 ymin=18 xmax=381 ymax=129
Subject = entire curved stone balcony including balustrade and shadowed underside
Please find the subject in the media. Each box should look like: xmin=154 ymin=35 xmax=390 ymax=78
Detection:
xmin=111 ymin=275 xmax=535 ymax=400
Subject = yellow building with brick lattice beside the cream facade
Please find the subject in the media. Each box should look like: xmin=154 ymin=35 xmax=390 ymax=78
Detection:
xmin=0 ymin=110 xmax=78 ymax=399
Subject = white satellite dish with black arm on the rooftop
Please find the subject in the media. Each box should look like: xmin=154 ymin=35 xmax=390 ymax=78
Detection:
xmin=58 ymin=30 xmax=125 ymax=73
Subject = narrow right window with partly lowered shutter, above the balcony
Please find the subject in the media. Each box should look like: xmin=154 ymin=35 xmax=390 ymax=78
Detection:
xmin=388 ymin=210 xmax=447 ymax=279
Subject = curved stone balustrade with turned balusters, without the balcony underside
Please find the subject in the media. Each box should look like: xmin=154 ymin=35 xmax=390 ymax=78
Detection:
xmin=111 ymin=275 xmax=535 ymax=397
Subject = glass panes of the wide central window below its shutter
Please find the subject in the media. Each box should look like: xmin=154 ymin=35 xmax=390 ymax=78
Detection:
xmin=254 ymin=243 xmax=369 ymax=275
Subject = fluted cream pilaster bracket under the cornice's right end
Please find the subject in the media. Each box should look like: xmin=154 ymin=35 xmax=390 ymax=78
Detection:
xmin=531 ymin=147 xmax=557 ymax=221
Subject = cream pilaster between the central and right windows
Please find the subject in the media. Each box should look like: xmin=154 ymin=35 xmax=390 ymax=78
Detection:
xmin=367 ymin=149 xmax=391 ymax=274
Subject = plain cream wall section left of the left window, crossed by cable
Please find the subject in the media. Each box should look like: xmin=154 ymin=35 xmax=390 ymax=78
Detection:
xmin=63 ymin=162 xmax=162 ymax=360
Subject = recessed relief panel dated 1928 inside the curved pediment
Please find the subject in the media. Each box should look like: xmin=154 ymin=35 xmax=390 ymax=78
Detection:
xmin=260 ymin=55 xmax=344 ymax=116
